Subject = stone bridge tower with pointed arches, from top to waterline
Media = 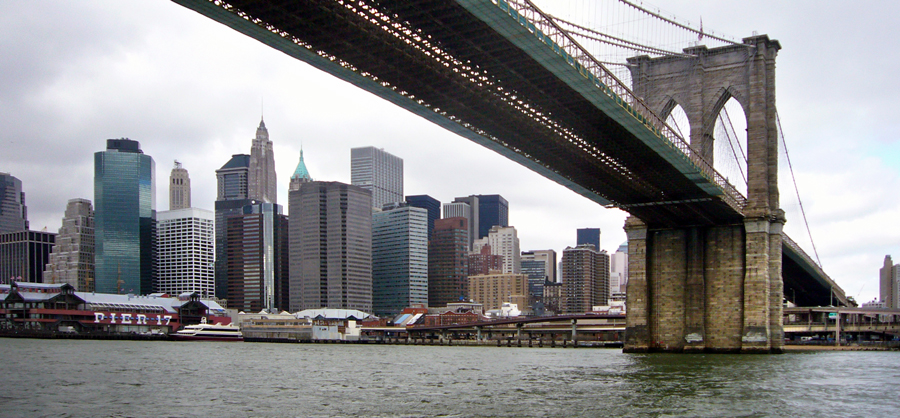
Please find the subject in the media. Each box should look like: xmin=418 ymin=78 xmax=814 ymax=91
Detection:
xmin=625 ymin=35 xmax=785 ymax=353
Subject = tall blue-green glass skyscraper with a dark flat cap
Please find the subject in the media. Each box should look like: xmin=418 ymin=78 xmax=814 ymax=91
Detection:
xmin=94 ymin=138 xmax=156 ymax=294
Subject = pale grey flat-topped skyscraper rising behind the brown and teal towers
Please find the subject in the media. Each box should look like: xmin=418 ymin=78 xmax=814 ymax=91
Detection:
xmin=350 ymin=147 xmax=403 ymax=209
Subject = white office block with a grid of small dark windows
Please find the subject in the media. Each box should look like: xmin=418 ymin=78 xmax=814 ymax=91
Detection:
xmin=156 ymin=208 xmax=215 ymax=296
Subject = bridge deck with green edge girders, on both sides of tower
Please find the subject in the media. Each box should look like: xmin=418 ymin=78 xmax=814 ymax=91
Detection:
xmin=173 ymin=0 xmax=843 ymax=305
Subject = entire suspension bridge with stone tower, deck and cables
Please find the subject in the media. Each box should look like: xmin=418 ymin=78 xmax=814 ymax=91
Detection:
xmin=174 ymin=0 xmax=847 ymax=352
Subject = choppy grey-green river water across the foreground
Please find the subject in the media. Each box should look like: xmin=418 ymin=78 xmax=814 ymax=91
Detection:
xmin=0 ymin=338 xmax=900 ymax=417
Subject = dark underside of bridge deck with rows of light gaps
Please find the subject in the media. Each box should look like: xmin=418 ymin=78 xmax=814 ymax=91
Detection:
xmin=209 ymin=0 xmax=741 ymax=227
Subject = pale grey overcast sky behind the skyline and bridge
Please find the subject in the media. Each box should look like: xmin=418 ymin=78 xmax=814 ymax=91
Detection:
xmin=0 ymin=0 xmax=900 ymax=302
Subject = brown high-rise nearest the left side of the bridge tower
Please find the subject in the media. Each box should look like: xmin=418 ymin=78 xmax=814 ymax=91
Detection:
xmin=562 ymin=244 xmax=609 ymax=314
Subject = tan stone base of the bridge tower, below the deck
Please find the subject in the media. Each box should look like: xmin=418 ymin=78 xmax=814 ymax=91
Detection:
xmin=625 ymin=218 xmax=783 ymax=353
